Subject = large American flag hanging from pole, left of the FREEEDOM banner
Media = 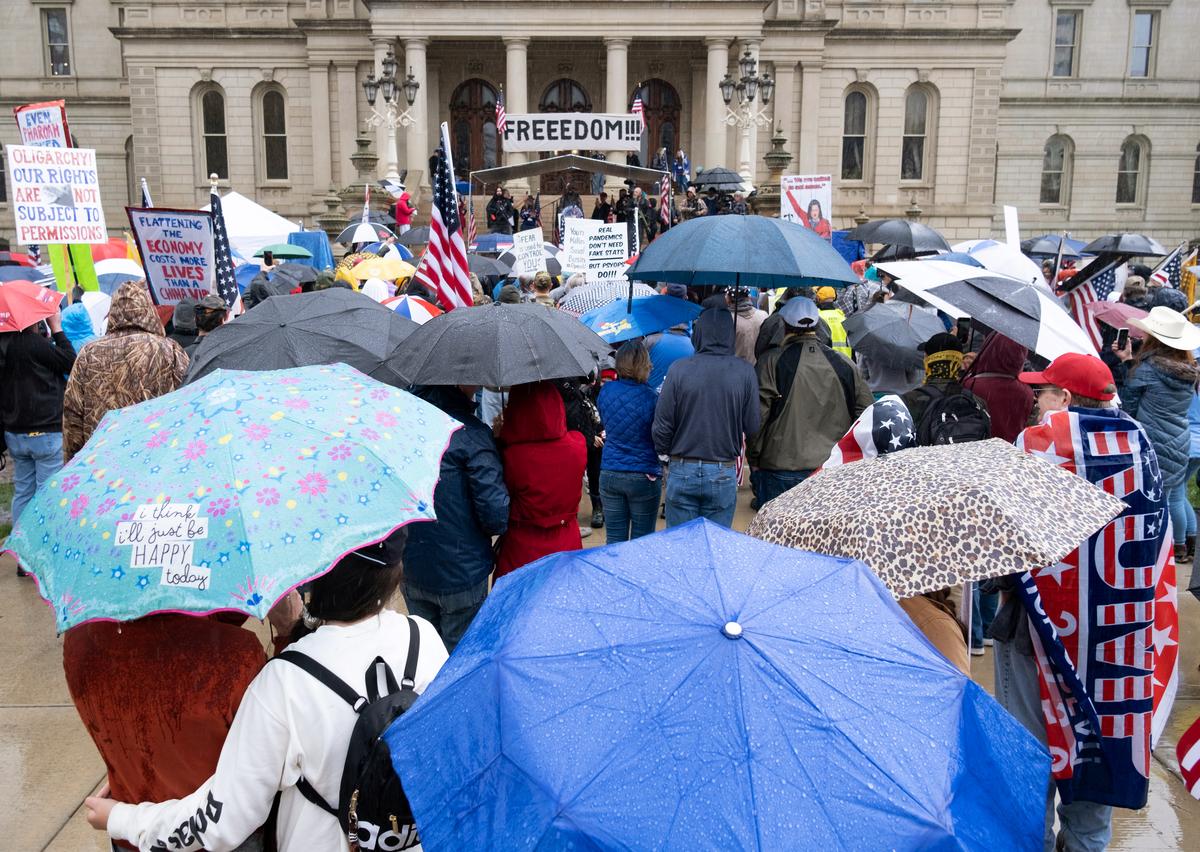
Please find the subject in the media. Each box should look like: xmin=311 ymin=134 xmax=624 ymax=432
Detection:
xmin=413 ymin=124 xmax=474 ymax=311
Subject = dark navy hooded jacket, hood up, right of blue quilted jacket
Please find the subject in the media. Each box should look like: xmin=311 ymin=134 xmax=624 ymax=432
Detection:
xmin=653 ymin=307 xmax=760 ymax=461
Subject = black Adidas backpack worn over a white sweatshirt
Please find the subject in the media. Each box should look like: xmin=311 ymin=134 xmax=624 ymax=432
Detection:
xmin=275 ymin=618 xmax=421 ymax=852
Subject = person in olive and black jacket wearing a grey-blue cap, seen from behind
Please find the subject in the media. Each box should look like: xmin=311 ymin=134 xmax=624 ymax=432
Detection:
xmin=746 ymin=296 xmax=875 ymax=505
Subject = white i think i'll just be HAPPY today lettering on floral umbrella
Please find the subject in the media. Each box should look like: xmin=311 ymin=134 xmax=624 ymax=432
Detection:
xmin=116 ymin=503 xmax=212 ymax=592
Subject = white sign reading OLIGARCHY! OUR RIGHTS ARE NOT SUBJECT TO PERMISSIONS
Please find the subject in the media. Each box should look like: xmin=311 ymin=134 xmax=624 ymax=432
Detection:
xmin=8 ymin=145 xmax=108 ymax=246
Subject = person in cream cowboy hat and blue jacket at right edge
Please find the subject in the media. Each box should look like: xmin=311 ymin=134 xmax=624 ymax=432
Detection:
xmin=1118 ymin=306 xmax=1200 ymax=562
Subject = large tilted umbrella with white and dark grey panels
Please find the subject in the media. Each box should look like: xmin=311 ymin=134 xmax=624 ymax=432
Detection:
xmin=876 ymin=260 xmax=1096 ymax=360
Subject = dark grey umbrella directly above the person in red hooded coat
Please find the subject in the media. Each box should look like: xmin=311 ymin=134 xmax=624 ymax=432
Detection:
xmin=396 ymin=305 xmax=610 ymax=388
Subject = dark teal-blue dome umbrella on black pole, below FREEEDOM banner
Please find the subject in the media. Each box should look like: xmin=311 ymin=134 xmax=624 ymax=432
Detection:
xmin=626 ymin=216 xmax=858 ymax=287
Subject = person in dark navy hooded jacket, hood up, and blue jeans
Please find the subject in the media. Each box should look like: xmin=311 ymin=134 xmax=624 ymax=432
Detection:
xmin=653 ymin=307 xmax=760 ymax=527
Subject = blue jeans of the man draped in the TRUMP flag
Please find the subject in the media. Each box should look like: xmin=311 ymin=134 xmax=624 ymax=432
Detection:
xmin=995 ymin=640 xmax=1112 ymax=852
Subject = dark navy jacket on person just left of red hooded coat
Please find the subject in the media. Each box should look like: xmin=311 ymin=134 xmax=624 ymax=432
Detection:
xmin=404 ymin=386 xmax=509 ymax=594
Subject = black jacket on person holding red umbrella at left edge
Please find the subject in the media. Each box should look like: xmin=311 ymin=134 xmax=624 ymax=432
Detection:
xmin=0 ymin=326 xmax=76 ymax=433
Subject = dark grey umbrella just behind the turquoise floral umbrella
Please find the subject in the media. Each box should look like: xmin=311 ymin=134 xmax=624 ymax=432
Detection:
xmin=186 ymin=288 xmax=417 ymax=388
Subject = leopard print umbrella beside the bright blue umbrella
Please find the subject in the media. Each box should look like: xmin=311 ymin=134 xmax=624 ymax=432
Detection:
xmin=746 ymin=439 xmax=1124 ymax=598
